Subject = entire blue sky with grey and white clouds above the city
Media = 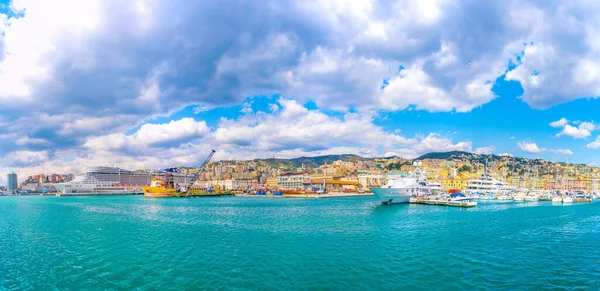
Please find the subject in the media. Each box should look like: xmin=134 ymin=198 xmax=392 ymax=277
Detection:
xmin=0 ymin=0 xmax=600 ymax=184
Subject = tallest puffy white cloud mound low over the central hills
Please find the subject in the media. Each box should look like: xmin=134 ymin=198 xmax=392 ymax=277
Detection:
xmin=214 ymin=99 xmax=417 ymax=151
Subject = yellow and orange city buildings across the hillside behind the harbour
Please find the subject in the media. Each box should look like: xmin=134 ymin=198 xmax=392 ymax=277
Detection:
xmin=5 ymin=153 xmax=600 ymax=192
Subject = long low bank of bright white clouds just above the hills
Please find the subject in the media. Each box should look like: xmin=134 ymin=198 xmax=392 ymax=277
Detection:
xmin=38 ymin=99 xmax=473 ymax=175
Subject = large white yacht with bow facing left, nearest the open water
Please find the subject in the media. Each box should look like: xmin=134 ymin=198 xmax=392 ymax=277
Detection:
xmin=369 ymin=162 xmax=433 ymax=204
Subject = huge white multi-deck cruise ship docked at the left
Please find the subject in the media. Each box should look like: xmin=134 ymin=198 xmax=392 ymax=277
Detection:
xmin=51 ymin=167 xmax=197 ymax=194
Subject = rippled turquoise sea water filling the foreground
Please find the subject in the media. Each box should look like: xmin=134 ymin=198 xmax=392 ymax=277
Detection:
xmin=0 ymin=196 xmax=600 ymax=290
